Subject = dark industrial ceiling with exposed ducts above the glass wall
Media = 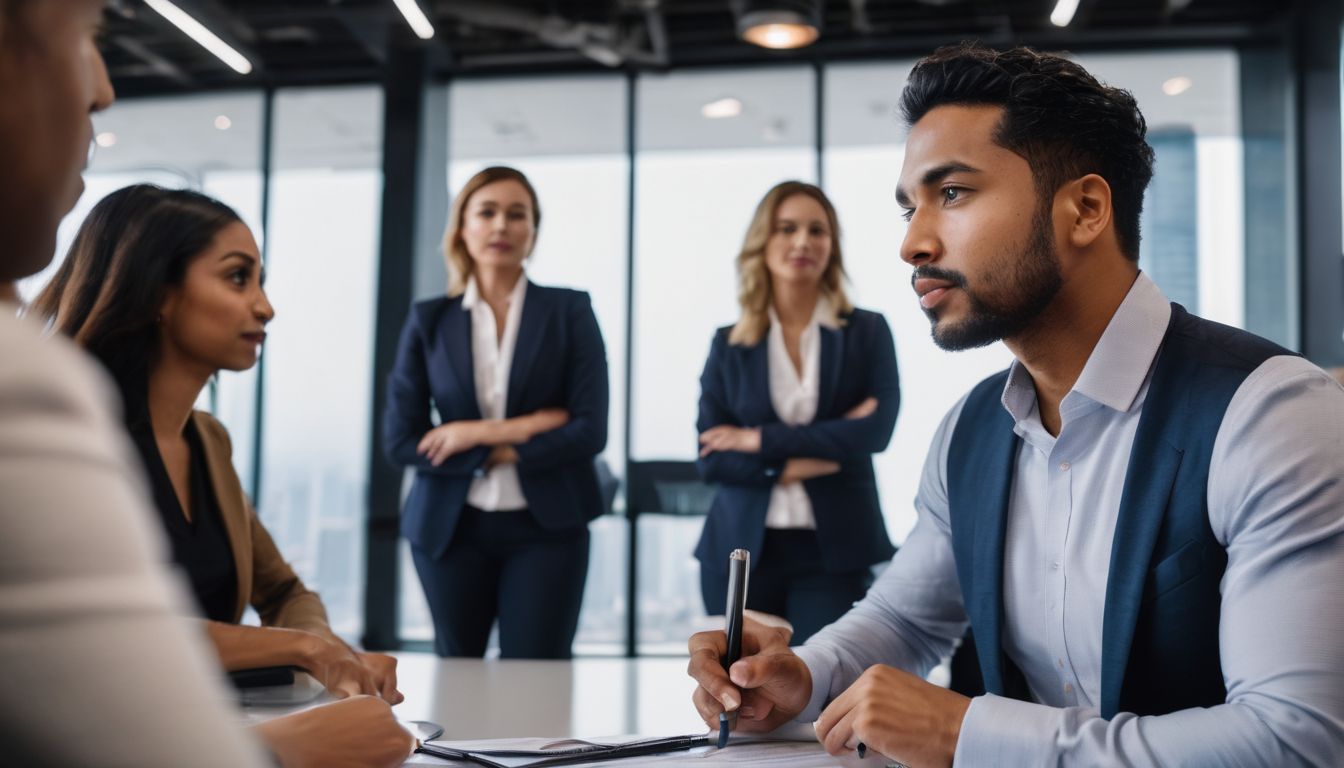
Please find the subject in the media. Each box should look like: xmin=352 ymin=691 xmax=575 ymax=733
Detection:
xmin=101 ymin=0 xmax=1296 ymax=95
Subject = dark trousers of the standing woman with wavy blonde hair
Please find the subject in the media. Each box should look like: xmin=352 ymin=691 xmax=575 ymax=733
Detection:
xmin=700 ymin=529 xmax=872 ymax=646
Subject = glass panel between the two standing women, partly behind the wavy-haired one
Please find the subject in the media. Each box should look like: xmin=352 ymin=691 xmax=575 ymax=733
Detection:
xmin=630 ymin=67 xmax=817 ymax=654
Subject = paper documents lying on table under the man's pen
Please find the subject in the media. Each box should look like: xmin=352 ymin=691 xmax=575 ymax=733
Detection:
xmin=406 ymin=724 xmax=884 ymax=768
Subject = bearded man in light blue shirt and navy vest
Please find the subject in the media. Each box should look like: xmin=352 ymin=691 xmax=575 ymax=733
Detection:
xmin=689 ymin=46 xmax=1344 ymax=767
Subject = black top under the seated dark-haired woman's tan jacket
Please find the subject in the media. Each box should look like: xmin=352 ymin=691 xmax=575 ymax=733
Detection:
xmin=128 ymin=420 xmax=238 ymax=623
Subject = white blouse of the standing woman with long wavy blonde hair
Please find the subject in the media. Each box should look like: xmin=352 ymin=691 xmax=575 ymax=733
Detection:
xmin=765 ymin=297 xmax=837 ymax=529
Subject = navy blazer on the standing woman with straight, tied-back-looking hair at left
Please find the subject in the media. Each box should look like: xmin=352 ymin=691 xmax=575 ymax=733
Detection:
xmin=383 ymin=282 xmax=609 ymax=557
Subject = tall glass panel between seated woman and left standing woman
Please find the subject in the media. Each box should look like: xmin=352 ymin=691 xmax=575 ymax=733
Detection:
xmin=258 ymin=87 xmax=383 ymax=639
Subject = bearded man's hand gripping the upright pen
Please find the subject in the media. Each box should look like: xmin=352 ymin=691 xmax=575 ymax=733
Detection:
xmin=687 ymin=616 xmax=812 ymax=733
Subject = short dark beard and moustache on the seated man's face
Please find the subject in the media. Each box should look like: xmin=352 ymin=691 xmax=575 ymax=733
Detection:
xmin=911 ymin=204 xmax=1064 ymax=351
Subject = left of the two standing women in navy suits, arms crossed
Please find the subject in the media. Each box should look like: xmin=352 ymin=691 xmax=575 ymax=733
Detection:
xmin=383 ymin=167 xmax=607 ymax=658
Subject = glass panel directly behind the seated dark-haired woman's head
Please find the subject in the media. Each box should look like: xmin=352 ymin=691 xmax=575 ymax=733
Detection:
xmin=19 ymin=93 xmax=263 ymax=492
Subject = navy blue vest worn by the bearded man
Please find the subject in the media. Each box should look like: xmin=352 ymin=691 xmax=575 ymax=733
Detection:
xmin=946 ymin=304 xmax=1293 ymax=718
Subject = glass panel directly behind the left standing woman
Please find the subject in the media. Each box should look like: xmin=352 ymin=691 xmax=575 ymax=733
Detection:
xmin=401 ymin=77 xmax=630 ymax=654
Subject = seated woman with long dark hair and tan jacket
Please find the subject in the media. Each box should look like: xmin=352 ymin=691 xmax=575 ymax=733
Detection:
xmin=31 ymin=184 xmax=402 ymax=703
